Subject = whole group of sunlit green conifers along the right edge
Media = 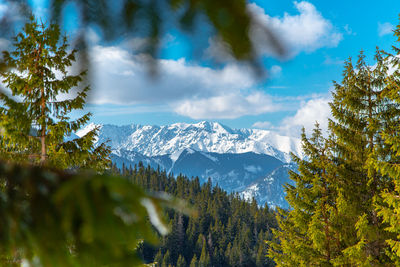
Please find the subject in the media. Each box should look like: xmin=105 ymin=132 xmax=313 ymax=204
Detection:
xmin=269 ymin=21 xmax=400 ymax=266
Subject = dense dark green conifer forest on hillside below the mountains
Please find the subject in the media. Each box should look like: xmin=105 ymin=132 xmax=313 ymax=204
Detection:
xmin=121 ymin=164 xmax=276 ymax=266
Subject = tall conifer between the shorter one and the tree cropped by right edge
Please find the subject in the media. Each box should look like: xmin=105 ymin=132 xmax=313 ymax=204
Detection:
xmin=330 ymin=51 xmax=393 ymax=266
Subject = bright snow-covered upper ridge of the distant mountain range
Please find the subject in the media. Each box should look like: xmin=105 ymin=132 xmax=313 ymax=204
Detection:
xmin=77 ymin=121 xmax=301 ymax=162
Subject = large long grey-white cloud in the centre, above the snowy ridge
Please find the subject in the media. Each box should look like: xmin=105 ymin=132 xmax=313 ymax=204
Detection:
xmin=82 ymin=45 xmax=282 ymax=119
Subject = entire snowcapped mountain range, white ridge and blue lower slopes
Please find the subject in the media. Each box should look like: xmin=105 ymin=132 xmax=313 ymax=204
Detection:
xmin=76 ymin=121 xmax=301 ymax=207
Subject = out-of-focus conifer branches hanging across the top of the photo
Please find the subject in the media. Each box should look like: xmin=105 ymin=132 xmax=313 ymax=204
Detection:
xmin=0 ymin=0 xmax=286 ymax=75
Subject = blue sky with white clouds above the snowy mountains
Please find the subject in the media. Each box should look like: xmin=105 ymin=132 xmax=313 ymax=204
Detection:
xmin=17 ymin=0 xmax=400 ymax=135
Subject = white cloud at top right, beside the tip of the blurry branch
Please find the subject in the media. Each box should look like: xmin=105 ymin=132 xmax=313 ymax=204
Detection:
xmin=206 ymin=1 xmax=343 ymax=60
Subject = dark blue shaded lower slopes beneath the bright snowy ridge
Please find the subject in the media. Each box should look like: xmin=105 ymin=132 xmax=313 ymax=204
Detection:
xmin=111 ymin=149 xmax=284 ymax=198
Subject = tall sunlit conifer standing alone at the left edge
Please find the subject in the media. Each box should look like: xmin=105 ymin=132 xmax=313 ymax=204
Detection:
xmin=0 ymin=17 xmax=110 ymax=170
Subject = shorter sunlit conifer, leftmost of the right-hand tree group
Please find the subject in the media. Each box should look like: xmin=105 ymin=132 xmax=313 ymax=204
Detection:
xmin=268 ymin=124 xmax=339 ymax=266
